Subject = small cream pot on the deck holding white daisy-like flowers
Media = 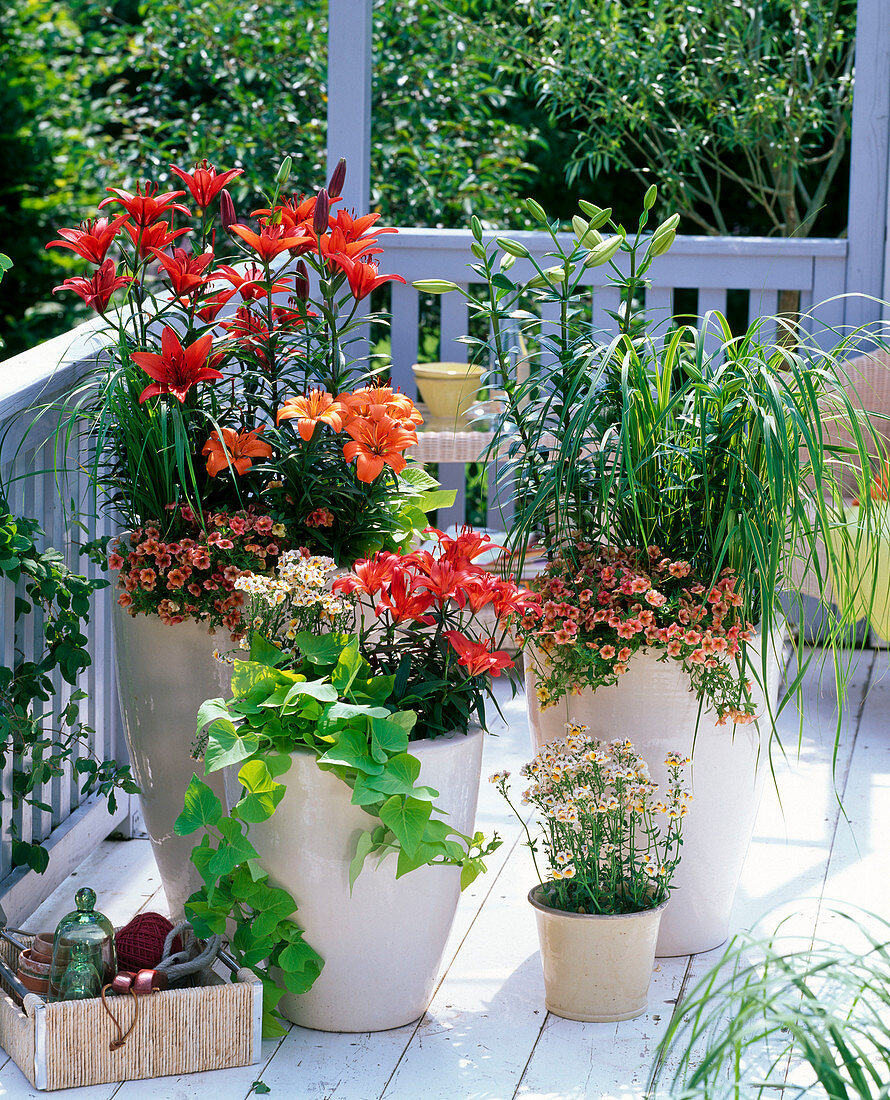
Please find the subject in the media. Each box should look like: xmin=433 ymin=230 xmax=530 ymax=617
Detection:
xmin=528 ymin=886 xmax=668 ymax=1023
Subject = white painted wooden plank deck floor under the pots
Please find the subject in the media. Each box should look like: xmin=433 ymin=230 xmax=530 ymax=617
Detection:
xmin=0 ymin=650 xmax=890 ymax=1100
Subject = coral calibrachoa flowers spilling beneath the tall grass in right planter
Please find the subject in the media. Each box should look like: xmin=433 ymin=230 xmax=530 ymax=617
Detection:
xmin=516 ymin=543 xmax=755 ymax=724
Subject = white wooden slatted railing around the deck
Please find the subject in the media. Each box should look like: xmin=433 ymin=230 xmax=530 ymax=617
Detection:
xmin=0 ymin=229 xmax=847 ymax=921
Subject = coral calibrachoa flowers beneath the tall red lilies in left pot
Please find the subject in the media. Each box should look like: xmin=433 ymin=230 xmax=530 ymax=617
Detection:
xmin=108 ymin=506 xmax=287 ymax=637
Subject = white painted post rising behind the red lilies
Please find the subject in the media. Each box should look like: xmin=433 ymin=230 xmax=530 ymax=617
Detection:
xmin=328 ymin=0 xmax=372 ymax=213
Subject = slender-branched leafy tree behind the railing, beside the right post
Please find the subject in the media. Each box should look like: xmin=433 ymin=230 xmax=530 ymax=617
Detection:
xmin=501 ymin=0 xmax=856 ymax=237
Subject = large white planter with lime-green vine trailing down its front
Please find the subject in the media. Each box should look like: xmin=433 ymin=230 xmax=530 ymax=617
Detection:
xmin=243 ymin=729 xmax=482 ymax=1032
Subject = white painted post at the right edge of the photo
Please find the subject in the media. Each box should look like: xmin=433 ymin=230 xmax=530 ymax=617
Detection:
xmin=845 ymin=0 xmax=890 ymax=326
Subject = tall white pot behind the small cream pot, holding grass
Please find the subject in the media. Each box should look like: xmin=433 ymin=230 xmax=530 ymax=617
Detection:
xmin=526 ymin=636 xmax=782 ymax=956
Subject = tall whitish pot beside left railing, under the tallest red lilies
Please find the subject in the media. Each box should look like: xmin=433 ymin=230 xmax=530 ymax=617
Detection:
xmin=114 ymin=605 xmax=231 ymax=917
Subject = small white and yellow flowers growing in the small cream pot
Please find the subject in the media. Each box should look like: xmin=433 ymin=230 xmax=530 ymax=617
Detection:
xmin=490 ymin=725 xmax=691 ymax=913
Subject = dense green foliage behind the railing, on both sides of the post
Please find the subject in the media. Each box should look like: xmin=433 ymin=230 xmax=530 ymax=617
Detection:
xmin=0 ymin=0 xmax=855 ymax=354
